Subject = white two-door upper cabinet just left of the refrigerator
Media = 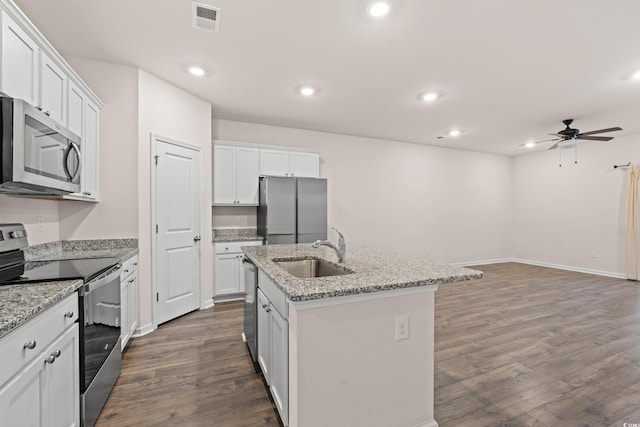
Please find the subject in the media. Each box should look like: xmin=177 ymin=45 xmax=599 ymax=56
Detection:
xmin=212 ymin=143 xmax=258 ymax=206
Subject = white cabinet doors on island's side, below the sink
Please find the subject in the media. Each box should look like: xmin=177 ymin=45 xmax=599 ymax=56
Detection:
xmin=258 ymin=274 xmax=289 ymax=426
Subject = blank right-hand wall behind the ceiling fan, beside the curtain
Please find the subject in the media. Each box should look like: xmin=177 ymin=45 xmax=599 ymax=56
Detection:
xmin=513 ymin=136 xmax=640 ymax=274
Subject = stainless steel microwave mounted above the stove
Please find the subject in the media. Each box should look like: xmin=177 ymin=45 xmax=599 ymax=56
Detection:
xmin=0 ymin=97 xmax=81 ymax=196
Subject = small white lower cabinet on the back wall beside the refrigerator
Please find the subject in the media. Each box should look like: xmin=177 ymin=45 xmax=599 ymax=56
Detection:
xmin=213 ymin=240 xmax=262 ymax=301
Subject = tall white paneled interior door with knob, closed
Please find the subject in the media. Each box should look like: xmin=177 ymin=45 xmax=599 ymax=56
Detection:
xmin=153 ymin=136 xmax=203 ymax=325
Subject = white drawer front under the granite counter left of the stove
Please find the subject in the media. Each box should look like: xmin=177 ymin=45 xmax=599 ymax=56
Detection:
xmin=0 ymin=292 xmax=78 ymax=386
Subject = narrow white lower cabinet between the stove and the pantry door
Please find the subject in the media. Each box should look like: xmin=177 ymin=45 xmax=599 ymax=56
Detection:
xmin=120 ymin=255 xmax=138 ymax=350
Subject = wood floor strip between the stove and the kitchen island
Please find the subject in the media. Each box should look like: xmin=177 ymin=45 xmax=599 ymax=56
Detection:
xmin=96 ymin=302 xmax=281 ymax=427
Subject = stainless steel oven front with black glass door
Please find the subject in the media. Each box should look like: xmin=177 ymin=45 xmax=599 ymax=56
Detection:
xmin=78 ymin=264 xmax=122 ymax=427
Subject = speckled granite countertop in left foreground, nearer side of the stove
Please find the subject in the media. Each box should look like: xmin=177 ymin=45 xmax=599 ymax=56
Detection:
xmin=0 ymin=280 xmax=82 ymax=338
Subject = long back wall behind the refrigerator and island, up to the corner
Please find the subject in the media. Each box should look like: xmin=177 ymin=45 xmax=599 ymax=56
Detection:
xmin=212 ymin=120 xmax=512 ymax=262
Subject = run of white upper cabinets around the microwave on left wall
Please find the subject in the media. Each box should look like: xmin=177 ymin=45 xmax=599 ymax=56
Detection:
xmin=0 ymin=0 xmax=104 ymax=202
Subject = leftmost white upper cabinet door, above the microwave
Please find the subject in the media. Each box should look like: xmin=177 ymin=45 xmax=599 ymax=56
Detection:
xmin=1 ymin=11 xmax=40 ymax=105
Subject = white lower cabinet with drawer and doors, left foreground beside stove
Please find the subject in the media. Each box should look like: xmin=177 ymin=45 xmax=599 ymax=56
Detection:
xmin=0 ymin=293 xmax=80 ymax=427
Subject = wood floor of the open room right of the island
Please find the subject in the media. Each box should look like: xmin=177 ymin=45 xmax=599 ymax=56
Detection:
xmin=435 ymin=263 xmax=640 ymax=427
